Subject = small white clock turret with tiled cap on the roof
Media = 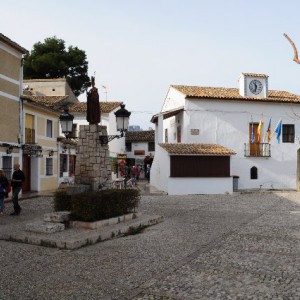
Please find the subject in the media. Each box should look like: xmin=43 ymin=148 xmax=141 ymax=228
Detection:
xmin=239 ymin=73 xmax=269 ymax=98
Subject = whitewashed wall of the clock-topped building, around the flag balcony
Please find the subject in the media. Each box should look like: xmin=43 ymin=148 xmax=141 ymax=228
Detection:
xmin=156 ymin=89 xmax=300 ymax=189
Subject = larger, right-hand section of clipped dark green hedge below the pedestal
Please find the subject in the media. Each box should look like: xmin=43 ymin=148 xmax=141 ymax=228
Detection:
xmin=71 ymin=189 xmax=140 ymax=222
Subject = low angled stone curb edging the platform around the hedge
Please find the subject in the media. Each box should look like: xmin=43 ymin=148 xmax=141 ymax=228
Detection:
xmin=0 ymin=216 xmax=164 ymax=250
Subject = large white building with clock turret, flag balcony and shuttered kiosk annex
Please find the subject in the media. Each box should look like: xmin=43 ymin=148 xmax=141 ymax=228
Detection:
xmin=151 ymin=73 xmax=300 ymax=194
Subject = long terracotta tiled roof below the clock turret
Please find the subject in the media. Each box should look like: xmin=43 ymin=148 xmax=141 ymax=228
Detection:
xmin=171 ymin=85 xmax=300 ymax=103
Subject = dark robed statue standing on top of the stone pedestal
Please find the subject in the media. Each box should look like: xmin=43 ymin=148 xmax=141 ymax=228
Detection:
xmin=86 ymin=76 xmax=100 ymax=125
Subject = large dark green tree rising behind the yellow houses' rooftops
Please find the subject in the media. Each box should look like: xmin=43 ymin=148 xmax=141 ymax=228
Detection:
xmin=24 ymin=36 xmax=90 ymax=96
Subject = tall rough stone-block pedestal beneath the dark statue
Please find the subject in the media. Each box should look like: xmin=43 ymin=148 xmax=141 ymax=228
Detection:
xmin=75 ymin=125 xmax=111 ymax=191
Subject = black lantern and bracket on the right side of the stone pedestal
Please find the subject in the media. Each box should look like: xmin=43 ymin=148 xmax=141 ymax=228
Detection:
xmin=99 ymin=104 xmax=131 ymax=145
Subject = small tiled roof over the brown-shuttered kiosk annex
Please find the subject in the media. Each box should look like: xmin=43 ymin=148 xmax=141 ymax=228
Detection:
xmin=159 ymin=143 xmax=236 ymax=156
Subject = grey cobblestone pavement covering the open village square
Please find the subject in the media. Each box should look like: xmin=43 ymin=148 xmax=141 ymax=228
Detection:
xmin=0 ymin=192 xmax=300 ymax=300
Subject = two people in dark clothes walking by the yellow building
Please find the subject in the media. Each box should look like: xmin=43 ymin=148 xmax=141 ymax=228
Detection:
xmin=0 ymin=163 xmax=25 ymax=216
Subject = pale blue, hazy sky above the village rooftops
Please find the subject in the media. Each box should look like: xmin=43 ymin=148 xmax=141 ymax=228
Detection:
xmin=0 ymin=0 xmax=300 ymax=130
